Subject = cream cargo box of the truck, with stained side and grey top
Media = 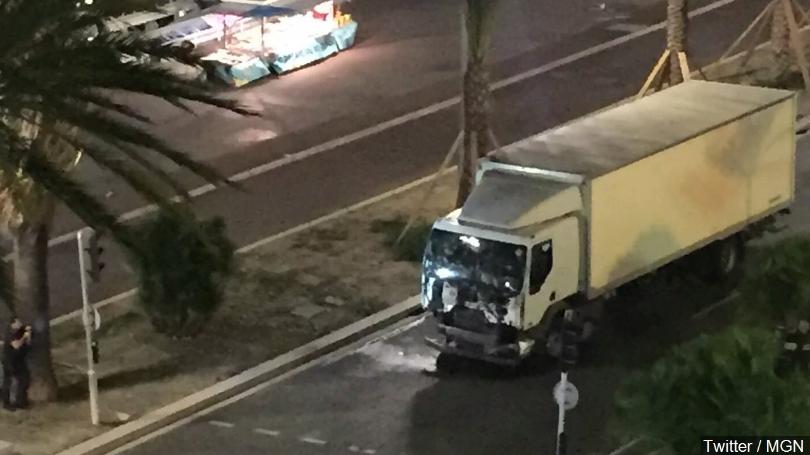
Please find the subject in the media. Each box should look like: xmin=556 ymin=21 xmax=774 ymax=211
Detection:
xmin=482 ymin=81 xmax=796 ymax=297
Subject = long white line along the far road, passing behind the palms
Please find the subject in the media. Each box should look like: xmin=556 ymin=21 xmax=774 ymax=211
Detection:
xmin=41 ymin=0 xmax=737 ymax=253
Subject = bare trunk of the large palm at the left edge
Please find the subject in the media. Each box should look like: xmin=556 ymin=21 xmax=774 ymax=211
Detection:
xmin=14 ymin=208 xmax=57 ymax=401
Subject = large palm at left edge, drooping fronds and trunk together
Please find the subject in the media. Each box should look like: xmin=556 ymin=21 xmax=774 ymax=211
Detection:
xmin=0 ymin=0 xmax=249 ymax=400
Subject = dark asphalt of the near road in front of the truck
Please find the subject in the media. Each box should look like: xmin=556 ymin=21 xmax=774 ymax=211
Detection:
xmin=116 ymin=130 xmax=810 ymax=455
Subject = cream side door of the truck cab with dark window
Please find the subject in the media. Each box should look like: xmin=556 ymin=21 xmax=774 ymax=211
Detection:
xmin=523 ymin=217 xmax=580 ymax=330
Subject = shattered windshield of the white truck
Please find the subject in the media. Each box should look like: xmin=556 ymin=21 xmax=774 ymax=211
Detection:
xmin=423 ymin=229 xmax=526 ymax=298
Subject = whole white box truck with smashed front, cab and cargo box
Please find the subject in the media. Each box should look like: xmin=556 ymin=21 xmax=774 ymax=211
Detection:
xmin=421 ymin=80 xmax=796 ymax=365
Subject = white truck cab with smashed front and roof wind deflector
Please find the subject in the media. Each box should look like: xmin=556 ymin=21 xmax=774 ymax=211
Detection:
xmin=421 ymin=163 xmax=582 ymax=364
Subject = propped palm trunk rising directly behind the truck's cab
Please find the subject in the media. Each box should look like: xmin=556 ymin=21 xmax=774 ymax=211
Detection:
xmin=456 ymin=0 xmax=500 ymax=207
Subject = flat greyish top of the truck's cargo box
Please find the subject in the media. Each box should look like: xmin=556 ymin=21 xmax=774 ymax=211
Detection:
xmin=490 ymin=81 xmax=794 ymax=178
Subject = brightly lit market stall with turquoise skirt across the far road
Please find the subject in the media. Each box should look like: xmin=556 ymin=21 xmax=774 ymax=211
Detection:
xmin=152 ymin=0 xmax=358 ymax=87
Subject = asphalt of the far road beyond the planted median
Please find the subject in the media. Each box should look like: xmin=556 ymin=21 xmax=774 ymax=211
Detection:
xmin=23 ymin=0 xmax=766 ymax=324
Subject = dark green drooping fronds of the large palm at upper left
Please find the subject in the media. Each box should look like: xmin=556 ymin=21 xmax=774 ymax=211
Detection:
xmin=0 ymin=0 xmax=256 ymax=260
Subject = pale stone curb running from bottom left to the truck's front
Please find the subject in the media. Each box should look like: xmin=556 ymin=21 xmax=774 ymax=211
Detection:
xmin=57 ymin=296 xmax=420 ymax=455
